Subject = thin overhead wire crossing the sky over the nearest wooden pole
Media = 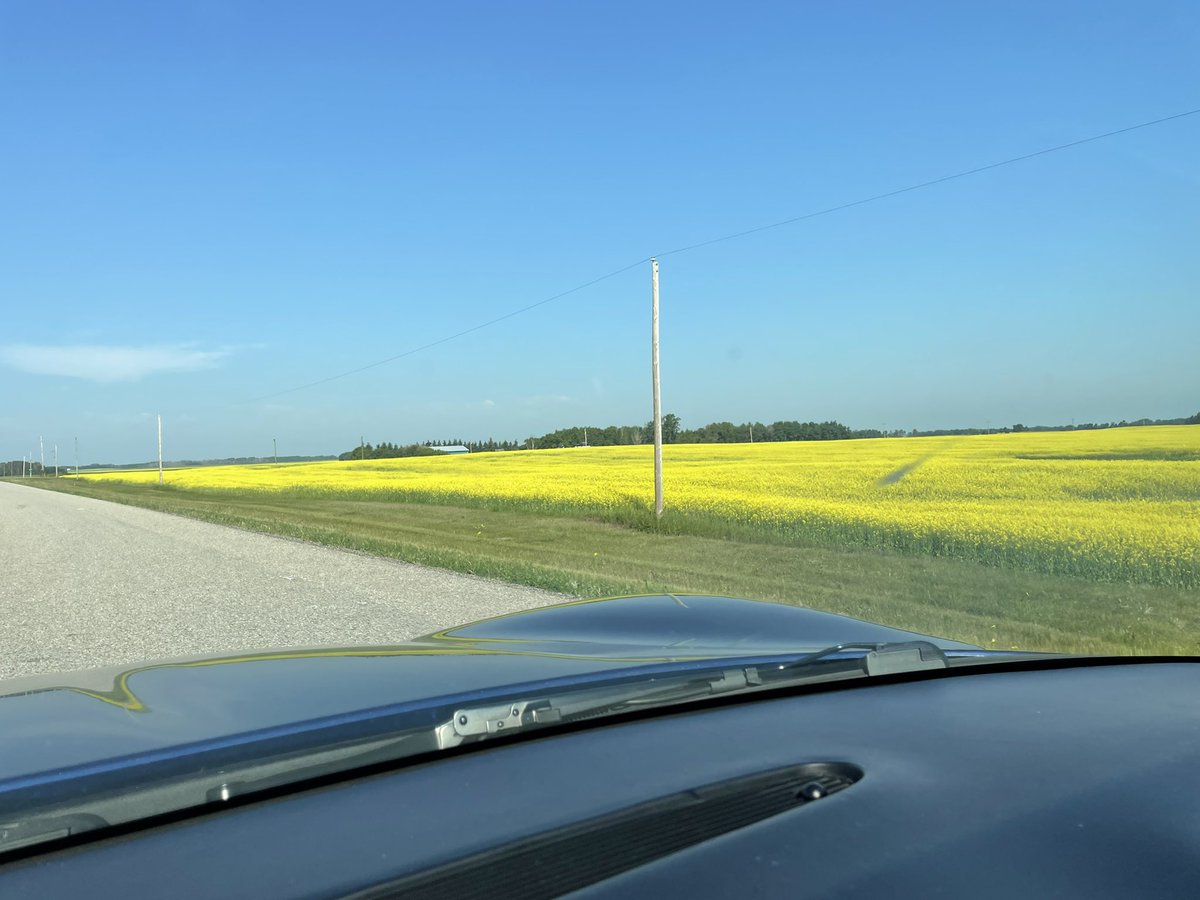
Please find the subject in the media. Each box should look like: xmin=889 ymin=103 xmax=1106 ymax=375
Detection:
xmin=241 ymin=108 xmax=1200 ymax=403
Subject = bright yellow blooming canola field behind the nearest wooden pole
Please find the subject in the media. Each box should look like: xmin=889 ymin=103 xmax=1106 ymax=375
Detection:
xmin=89 ymin=425 xmax=1200 ymax=587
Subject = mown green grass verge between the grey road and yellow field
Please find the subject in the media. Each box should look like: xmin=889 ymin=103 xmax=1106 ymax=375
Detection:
xmin=25 ymin=478 xmax=1200 ymax=654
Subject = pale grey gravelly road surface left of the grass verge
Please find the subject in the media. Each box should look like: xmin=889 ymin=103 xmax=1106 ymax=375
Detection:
xmin=0 ymin=482 xmax=565 ymax=678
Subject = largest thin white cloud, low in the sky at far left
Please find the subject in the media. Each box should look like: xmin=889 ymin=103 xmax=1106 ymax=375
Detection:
xmin=0 ymin=344 xmax=229 ymax=384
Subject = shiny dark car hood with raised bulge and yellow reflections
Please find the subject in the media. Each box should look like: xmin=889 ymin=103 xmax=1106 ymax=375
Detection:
xmin=0 ymin=595 xmax=982 ymax=794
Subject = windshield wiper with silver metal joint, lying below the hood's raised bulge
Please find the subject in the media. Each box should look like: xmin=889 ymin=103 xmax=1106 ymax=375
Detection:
xmin=434 ymin=641 xmax=949 ymax=750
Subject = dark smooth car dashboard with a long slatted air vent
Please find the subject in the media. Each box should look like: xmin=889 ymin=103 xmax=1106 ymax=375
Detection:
xmin=0 ymin=659 xmax=1200 ymax=898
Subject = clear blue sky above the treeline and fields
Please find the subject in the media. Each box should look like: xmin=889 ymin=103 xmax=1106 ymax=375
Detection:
xmin=0 ymin=0 xmax=1200 ymax=463
